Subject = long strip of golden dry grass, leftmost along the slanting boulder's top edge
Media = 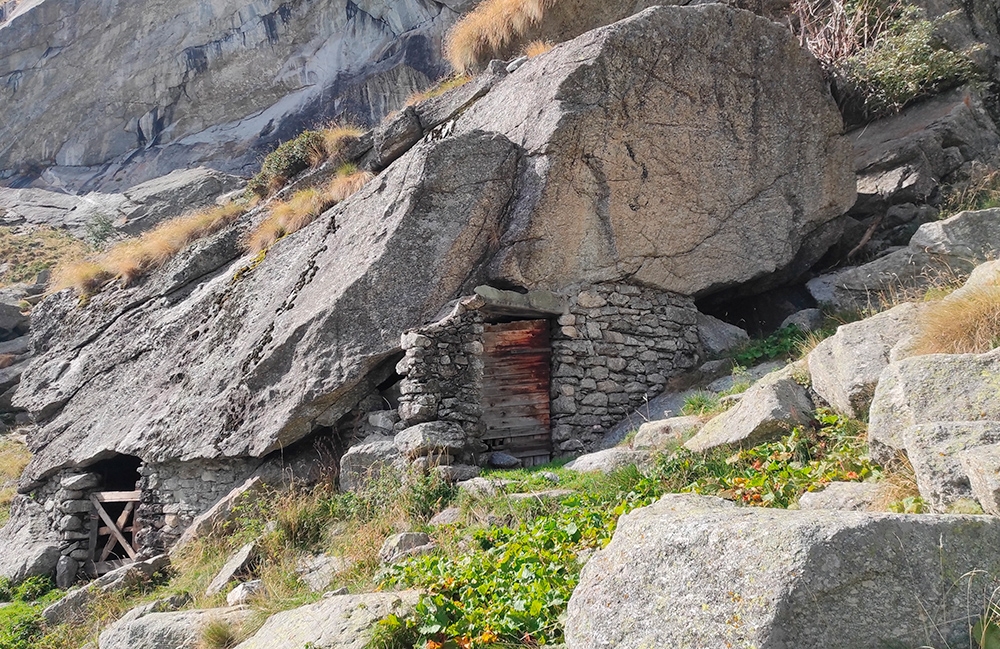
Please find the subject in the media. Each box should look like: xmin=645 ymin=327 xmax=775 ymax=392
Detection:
xmin=49 ymin=202 xmax=248 ymax=295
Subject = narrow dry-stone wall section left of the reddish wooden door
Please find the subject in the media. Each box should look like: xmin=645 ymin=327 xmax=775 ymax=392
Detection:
xmin=396 ymin=303 xmax=483 ymax=439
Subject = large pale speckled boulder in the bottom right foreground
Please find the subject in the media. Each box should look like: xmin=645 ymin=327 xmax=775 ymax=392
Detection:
xmin=566 ymin=495 xmax=1000 ymax=649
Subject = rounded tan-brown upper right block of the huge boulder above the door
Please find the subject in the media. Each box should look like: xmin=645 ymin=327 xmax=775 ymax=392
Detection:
xmin=456 ymin=5 xmax=855 ymax=295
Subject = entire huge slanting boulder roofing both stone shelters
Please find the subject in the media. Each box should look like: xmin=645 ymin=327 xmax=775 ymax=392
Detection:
xmin=11 ymin=6 xmax=854 ymax=496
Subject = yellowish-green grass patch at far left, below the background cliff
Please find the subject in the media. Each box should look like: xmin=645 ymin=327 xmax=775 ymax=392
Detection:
xmin=0 ymin=227 xmax=88 ymax=286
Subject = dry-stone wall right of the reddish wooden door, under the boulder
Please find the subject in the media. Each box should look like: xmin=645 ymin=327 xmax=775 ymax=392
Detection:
xmin=552 ymin=284 xmax=698 ymax=454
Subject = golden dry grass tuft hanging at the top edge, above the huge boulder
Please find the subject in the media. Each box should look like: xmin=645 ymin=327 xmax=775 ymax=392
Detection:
xmin=445 ymin=0 xmax=556 ymax=73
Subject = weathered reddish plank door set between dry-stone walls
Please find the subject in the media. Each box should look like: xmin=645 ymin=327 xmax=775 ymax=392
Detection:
xmin=483 ymin=320 xmax=552 ymax=466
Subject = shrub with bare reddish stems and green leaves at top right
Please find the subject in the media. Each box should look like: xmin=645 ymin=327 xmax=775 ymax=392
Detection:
xmin=793 ymin=0 xmax=980 ymax=125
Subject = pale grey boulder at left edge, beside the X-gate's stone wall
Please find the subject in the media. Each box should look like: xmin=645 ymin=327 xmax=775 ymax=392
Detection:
xmin=0 ymin=496 xmax=61 ymax=581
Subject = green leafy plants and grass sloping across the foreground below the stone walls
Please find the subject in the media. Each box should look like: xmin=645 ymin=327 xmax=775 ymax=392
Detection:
xmin=9 ymin=412 xmax=881 ymax=649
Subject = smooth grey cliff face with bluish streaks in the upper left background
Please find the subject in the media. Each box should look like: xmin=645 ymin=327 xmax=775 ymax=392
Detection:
xmin=0 ymin=0 xmax=469 ymax=188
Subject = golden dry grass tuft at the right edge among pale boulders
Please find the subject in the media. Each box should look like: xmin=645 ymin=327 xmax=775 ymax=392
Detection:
xmin=913 ymin=285 xmax=1000 ymax=354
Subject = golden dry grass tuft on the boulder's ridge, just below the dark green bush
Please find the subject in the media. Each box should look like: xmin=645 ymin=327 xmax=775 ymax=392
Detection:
xmin=244 ymin=165 xmax=373 ymax=253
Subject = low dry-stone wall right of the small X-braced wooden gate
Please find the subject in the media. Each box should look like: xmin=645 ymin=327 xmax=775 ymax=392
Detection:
xmin=136 ymin=460 xmax=259 ymax=553
